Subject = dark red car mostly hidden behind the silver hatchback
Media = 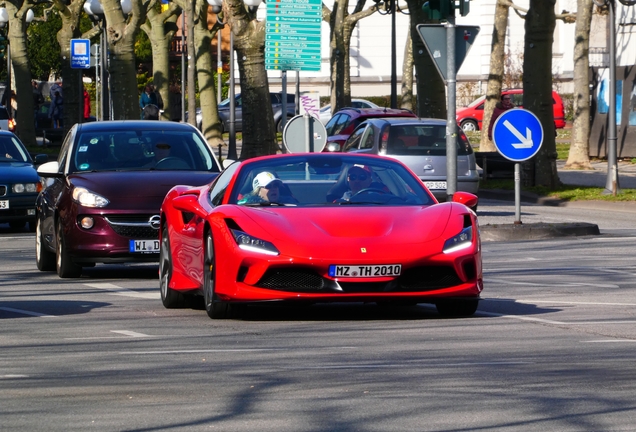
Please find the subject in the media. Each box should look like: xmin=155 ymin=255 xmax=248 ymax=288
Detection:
xmin=322 ymin=108 xmax=417 ymax=152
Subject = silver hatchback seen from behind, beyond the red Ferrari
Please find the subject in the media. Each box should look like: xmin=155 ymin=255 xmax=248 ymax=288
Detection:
xmin=343 ymin=118 xmax=479 ymax=201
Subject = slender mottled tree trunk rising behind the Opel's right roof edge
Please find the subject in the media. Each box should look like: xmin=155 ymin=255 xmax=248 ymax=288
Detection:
xmin=194 ymin=1 xmax=225 ymax=148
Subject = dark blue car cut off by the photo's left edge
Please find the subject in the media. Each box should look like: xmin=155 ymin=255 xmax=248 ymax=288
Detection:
xmin=0 ymin=130 xmax=48 ymax=231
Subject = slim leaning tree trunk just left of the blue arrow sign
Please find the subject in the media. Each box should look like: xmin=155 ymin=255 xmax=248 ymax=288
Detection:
xmin=479 ymin=1 xmax=509 ymax=152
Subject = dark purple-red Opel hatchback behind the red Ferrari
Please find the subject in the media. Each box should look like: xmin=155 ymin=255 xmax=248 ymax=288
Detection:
xmin=36 ymin=121 xmax=221 ymax=277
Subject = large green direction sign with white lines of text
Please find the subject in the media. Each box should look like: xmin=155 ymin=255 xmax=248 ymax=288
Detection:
xmin=265 ymin=0 xmax=322 ymax=71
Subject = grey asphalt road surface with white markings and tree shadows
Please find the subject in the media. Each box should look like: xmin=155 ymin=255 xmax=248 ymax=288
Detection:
xmin=0 ymin=202 xmax=636 ymax=432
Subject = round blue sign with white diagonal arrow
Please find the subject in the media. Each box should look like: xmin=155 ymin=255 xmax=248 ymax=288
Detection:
xmin=492 ymin=108 xmax=543 ymax=162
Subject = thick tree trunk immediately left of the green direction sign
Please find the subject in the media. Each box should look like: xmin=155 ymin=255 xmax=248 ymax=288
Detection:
xmin=223 ymin=0 xmax=279 ymax=159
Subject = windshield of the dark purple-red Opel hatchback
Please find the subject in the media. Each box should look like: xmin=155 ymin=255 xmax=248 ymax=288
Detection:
xmin=71 ymin=129 xmax=218 ymax=172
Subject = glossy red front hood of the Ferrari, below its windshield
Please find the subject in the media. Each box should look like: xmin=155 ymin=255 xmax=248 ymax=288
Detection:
xmin=242 ymin=205 xmax=451 ymax=246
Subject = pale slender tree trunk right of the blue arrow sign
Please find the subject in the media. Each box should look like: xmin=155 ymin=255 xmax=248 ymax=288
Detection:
xmin=565 ymin=0 xmax=593 ymax=169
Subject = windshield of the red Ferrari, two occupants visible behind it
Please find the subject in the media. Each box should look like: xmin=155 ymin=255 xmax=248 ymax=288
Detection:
xmin=229 ymin=154 xmax=435 ymax=207
